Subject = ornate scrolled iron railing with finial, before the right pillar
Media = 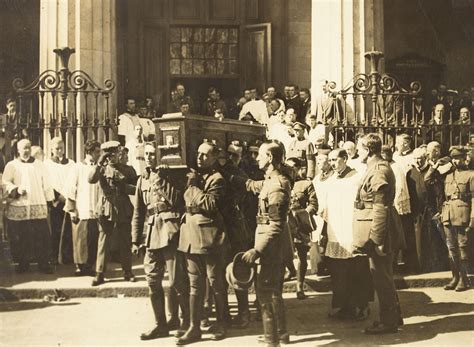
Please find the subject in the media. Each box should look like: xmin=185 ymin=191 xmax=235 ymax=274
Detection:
xmin=320 ymin=51 xmax=474 ymax=148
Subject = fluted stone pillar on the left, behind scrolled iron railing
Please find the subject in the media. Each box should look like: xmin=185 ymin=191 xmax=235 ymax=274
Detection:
xmin=40 ymin=0 xmax=117 ymax=159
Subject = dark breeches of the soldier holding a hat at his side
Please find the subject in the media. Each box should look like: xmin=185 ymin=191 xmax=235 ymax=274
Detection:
xmin=255 ymin=264 xmax=285 ymax=305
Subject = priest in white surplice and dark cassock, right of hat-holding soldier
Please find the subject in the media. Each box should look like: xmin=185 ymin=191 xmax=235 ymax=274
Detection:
xmin=323 ymin=148 xmax=374 ymax=320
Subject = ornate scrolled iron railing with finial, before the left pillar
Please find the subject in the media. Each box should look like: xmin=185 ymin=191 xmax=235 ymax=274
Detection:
xmin=13 ymin=47 xmax=118 ymax=159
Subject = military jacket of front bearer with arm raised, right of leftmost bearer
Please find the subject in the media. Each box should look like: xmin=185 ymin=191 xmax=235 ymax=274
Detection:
xmin=178 ymin=169 xmax=226 ymax=254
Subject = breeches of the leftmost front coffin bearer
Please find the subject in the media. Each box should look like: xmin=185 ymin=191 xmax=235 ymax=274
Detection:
xmin=143 ymin=245 xmax=189 ymax=296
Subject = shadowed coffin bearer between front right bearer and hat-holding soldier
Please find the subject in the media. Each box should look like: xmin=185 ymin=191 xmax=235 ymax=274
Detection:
xmin=220 ymin=141 xmax=252 ymax=329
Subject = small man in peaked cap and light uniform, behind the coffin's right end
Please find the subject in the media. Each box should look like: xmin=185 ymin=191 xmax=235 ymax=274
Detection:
xmin=286 ymin=122 xmax=315 ymax=179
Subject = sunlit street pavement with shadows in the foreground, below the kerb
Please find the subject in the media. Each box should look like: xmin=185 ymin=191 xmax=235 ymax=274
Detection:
xmin=0 ymin=288 xmax=474 ymax=347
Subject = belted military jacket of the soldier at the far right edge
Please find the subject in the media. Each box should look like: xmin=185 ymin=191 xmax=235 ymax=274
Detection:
xmin=441 ymin=169 xmax=474 ymax=227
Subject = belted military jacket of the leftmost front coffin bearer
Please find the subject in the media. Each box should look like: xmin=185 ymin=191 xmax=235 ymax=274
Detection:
xmin=132 ymin=168 xmax=183 ymax=250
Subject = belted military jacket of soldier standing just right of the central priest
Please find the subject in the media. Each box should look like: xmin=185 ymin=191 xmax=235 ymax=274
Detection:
xmin=353 ymin=159 xmax=402 ymax=253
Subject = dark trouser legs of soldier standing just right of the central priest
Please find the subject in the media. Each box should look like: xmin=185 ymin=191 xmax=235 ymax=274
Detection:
xmin=369 ymin=252 xmax=399 ymax=327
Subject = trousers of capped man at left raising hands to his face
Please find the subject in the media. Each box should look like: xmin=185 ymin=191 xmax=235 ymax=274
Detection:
xmin=96 ymin=218 xmax=132 ymax=274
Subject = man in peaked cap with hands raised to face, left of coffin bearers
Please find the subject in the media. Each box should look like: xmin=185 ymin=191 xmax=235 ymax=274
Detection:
xmin=89 ymin=141 xmax=135 ymax=286
